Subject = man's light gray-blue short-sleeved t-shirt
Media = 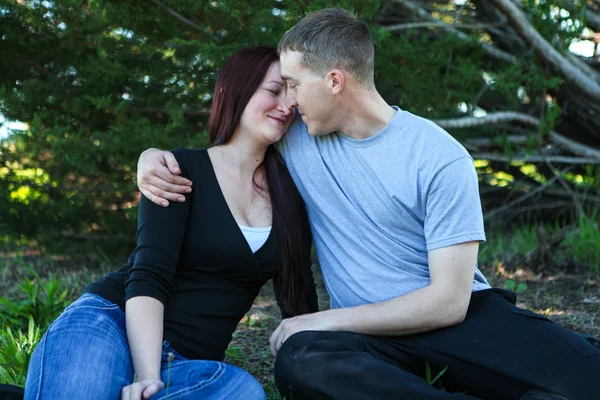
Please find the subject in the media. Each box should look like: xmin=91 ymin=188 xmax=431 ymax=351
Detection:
xmin=278 ymin=107 xmax=490 ymax=308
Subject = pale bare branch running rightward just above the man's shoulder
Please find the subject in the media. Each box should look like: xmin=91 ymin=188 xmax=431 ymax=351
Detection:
xmin=433 ymin=111 xmax=600 ymax=160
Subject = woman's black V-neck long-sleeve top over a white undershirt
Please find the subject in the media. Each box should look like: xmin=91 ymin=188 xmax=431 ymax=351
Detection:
xmin=85 ymin=149 xmax=318 ymax=360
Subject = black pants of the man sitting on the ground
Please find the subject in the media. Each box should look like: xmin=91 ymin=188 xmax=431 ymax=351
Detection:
xmin=275 ymin=289 xmax=600 ymax=400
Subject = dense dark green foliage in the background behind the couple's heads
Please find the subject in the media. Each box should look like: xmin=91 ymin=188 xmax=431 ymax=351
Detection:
xmin=0 ymin=0 xmax=600 ymax=254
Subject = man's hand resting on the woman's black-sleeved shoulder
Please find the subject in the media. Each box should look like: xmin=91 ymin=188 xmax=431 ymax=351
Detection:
xmin=137 ymin=149 xmax=192 ymax=207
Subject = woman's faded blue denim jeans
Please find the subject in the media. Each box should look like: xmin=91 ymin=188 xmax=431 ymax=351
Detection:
xmin=25 ymin=294 xmax=266 ymax=400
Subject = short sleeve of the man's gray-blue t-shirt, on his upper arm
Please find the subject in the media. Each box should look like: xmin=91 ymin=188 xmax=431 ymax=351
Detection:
xmin=424 ymin=156 xmax=485 ymax=251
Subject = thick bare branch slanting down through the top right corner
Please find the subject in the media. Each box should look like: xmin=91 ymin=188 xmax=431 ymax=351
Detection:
xmin=491 ymin=0 xmax=600 ymax=101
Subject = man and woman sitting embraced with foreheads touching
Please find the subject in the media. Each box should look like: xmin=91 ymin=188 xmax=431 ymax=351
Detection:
xmin=26 ymin=9 xmax=600 ymax=400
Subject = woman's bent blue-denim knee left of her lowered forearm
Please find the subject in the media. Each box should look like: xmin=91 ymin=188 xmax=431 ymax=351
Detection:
xmin=25 ymin=296 xmax=133 ymax=399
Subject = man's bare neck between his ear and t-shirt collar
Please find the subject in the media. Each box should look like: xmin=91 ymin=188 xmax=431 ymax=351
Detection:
xmin=338 ymin=90 xmax=396 ymax=140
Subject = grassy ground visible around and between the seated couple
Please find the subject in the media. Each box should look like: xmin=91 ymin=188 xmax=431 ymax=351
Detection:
xmin=0 ymin=217 xmax=600 ymax=400
